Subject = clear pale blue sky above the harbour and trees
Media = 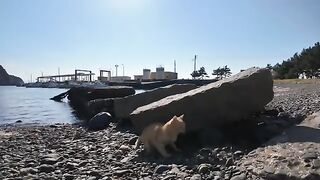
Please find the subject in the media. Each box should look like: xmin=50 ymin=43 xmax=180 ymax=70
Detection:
xmin=0 ymin=0 xmax=320 ymax=82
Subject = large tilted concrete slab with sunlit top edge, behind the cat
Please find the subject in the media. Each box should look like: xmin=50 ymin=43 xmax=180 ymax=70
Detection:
xmin=130 ymin=68 xmax=273 ymax=132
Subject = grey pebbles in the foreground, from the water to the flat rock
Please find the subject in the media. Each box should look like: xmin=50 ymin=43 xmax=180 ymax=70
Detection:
xmin=0 ymin=124 xmax=245 ymax=180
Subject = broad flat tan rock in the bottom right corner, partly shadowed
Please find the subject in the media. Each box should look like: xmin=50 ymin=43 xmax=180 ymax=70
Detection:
xmin=240 ymin=112 xmax=320 ymax=179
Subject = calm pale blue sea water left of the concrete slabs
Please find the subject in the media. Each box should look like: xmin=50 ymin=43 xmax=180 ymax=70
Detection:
xmin=0 ymin=86 xmax=80 ymax=124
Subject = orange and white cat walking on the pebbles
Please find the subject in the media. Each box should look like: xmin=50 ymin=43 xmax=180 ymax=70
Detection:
xmin=135 ymin=115 xmax=186 ymax=157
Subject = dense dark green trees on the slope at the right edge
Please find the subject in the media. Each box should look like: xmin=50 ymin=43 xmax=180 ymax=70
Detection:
xmin=272 ymin=42 xmax=320 ymax=79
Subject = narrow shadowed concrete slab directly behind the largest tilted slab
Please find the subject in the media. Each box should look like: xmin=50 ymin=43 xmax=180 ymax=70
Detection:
xmin=113 ymin=84 xmax=197 ymax=119
